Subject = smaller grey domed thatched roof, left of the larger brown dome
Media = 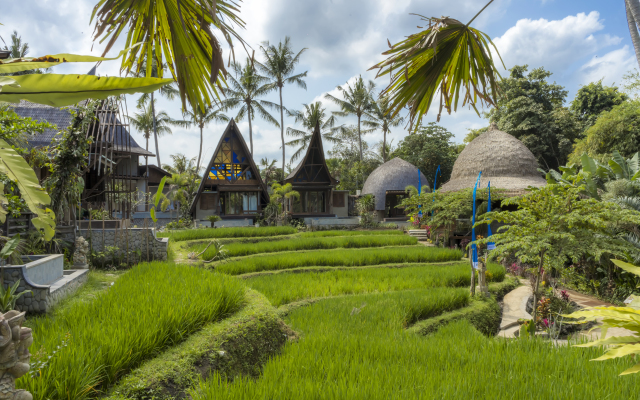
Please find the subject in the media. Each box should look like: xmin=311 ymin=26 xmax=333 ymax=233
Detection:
xmin=361 ymin=157 xmax=429 ymax=211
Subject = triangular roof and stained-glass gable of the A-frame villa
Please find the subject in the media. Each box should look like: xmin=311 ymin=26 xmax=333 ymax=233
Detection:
xmin=191 ymin=118 xmax=269 ymax=216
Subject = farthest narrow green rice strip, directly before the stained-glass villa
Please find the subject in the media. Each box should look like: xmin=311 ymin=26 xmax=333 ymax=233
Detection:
xmin=157 ymin=226 xmax=298 ymax=242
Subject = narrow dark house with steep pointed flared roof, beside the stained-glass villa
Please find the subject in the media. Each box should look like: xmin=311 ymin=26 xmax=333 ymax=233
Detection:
xmin=284 ymin=125 xmax=348 ymax=219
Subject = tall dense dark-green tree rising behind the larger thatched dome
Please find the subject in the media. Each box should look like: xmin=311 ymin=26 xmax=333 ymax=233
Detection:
xmin=489 ymin=65 xmax=581 ymax=170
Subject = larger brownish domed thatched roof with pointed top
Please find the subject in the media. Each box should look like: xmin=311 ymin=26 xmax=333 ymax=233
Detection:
xmin=440 ymin=124 xmax=546 ymax=196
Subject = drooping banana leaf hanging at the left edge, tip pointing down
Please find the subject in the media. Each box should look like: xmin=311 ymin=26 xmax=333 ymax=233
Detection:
xmin=0 ymin=139 xmax=56 ymax=241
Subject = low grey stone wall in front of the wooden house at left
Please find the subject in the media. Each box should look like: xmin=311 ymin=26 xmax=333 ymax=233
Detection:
xmin=78 ymin=228 xmax=169 ymax=261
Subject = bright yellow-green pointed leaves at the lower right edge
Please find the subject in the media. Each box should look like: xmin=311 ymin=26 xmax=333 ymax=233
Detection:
xmin=565 ymin=260 xmax=640 ymax=375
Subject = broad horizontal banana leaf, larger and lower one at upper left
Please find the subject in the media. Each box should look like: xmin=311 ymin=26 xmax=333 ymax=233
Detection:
xmin=0 ymin=74 xmax=173 ymax=107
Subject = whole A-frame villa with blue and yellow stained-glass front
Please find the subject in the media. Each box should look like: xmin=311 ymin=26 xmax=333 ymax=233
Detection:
xmin=191 ymin=119 xmax=269 ymax=223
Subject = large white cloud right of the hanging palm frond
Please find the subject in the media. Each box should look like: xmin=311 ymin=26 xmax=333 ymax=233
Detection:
xmin=494 ymin=11 xmax=622 ymax=72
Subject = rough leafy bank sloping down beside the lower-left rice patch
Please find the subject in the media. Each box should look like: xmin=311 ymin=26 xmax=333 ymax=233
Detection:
xmin=107 ymin=290 xmax=292 ymax=400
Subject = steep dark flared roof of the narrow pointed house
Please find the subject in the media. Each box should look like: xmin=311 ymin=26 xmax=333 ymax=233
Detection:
xmin=285 ymin=124 xmax=338 ymax=186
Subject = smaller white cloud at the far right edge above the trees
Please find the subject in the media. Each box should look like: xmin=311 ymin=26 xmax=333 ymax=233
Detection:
xmin=579 ymin=46 xmax=638 ymax=85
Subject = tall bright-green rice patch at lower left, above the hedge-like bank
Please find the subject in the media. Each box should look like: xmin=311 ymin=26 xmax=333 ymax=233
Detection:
xmin=19 ymin=262 xmax=245 ymax=400
